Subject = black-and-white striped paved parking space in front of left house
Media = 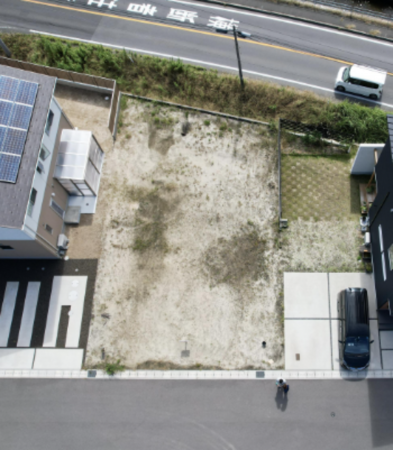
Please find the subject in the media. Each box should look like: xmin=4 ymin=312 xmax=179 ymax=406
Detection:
xmin=0 ymin=260 xmax=97 ymax=370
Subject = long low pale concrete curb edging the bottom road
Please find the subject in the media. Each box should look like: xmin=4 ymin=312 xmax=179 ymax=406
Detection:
xmin=0 ymin=370 xmax=393 ymax=381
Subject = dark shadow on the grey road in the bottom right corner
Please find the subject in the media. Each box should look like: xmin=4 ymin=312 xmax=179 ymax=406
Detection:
xmin=367 ymin=379 xmax=393 ymax=448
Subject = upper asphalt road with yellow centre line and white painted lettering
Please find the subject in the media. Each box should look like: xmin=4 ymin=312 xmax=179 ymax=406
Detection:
xmin=0 ymin=0 xmax=393 ymax=109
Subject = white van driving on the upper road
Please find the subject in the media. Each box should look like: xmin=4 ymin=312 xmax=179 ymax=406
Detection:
xmin=335 ymin=64 xmax=387 ymax=100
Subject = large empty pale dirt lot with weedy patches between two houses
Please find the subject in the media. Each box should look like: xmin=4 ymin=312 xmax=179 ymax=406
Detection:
xmin=85 ymin=100 xmax=283 ymax=369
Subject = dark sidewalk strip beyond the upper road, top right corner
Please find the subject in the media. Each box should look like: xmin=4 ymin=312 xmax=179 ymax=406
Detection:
xmin=201 ymin=0 xmax=393 ymax=40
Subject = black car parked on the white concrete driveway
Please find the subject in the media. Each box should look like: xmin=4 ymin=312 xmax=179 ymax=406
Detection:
xmin=338 ymin=288 xmax=373 ymax=371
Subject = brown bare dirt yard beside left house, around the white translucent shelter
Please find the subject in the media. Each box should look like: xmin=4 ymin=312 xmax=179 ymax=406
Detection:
xmin=55 ymin=85 xmax=113 ymax=259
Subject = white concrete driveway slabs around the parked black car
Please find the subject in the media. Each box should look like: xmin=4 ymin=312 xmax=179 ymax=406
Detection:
xmin=284 ymin=273 xmax=382 ymax=370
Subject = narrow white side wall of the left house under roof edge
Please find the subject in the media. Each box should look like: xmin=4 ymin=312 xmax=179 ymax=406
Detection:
xmin=25 ymin=97 xmax=61 ymax=234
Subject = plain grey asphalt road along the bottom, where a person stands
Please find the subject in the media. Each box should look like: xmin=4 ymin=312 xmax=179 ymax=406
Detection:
xmin=0 ymin=379 xmax=393 ymax=450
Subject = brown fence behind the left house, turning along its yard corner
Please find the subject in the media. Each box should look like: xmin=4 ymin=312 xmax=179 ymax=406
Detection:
xmin=0 ymin=56 xmax=119 ymax=135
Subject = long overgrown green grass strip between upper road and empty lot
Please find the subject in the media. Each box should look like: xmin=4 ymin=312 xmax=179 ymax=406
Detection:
xmin=0 ymin=34 xmax=388 ymax=142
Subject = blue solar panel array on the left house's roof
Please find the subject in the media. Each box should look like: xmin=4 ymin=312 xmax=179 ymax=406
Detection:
xmin=0 ymin=76 xmax=38 ymax=183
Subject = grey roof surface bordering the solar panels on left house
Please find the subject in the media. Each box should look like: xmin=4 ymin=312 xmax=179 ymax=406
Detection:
xmin=0 ymin=65 xmax=56 ymax=228
